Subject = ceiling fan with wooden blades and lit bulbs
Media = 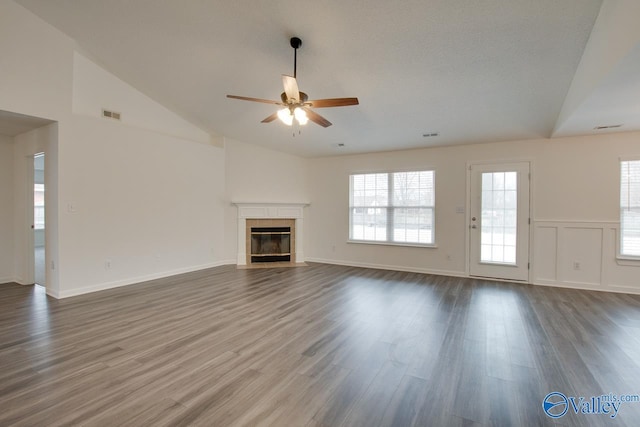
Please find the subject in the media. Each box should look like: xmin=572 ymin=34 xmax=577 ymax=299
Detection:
xmin=227 ymin=37 xmax=358 ymax=128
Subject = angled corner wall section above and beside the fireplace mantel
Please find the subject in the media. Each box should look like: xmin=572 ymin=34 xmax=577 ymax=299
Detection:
xmin=225 ymin=140 xmax=310 ymax=264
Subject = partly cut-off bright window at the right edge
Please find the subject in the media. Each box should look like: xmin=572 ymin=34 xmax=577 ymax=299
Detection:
xmin=620 ymin=160 xmax=640 ymax=257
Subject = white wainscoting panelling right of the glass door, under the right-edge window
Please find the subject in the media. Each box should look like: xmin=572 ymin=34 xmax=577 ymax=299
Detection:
xmin=532 ymin=221 xmax=640 ymax=293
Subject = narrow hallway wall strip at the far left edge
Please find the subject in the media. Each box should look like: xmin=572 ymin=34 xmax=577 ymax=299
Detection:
xmin=0 ymin=135 xmax=15 ymax=283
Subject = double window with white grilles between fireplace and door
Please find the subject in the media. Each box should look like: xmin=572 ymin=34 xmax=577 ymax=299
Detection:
xmin=349 ymin=171 xmax=435 ymax=245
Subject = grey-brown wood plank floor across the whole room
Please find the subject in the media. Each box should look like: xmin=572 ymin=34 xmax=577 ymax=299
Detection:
xmin=0 ymin=264 xmax=640 ymax=426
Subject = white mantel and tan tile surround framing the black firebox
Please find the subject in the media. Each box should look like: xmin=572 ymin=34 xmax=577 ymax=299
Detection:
xmin=233 ymin=202 xmax=309 ymax=266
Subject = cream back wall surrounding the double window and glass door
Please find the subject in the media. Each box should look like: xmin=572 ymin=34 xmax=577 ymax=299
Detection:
xmin=307 ymin=132 xmax=640 ymax=293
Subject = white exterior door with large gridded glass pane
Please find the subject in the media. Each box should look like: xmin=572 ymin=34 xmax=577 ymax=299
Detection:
xmin=468 ymin=163 xmax=530 ymax=281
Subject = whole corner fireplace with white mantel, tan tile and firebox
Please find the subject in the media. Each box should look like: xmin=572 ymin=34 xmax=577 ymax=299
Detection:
xmin=233 ymin=202 xmax=309 ymax=267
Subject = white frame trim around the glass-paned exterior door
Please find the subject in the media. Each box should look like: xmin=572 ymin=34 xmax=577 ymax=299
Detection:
xmin=464 ymin=158 xmax=535 ymax=284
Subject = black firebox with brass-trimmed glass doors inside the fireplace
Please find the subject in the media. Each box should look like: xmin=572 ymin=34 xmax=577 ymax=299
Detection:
xmin=249 ymin=227 xmax=291 ymax=263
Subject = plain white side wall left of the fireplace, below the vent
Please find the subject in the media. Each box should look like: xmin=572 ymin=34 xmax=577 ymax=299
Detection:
xmin=60 ymin=116 xmax=224 ymax=296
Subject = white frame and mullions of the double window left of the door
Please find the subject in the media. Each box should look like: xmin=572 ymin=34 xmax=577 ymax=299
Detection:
xmin=348 ymin=168 xmax=437 ymax=248
